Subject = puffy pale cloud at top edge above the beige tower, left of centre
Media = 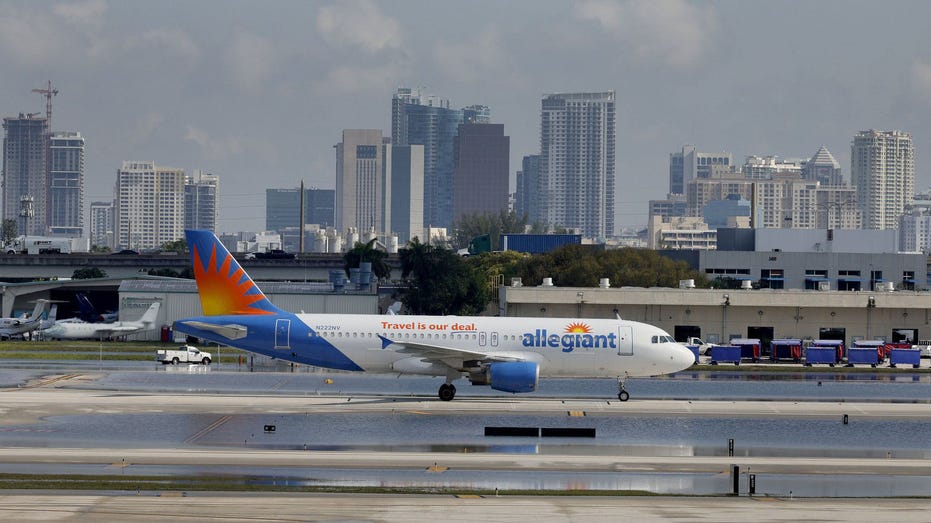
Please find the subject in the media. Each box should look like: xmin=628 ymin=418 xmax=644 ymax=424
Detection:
xmin=317 ymin=0 xmax=401 ymax=53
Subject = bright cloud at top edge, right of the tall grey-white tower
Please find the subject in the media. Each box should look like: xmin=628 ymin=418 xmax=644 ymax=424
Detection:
xmin=576 ymin=0 xmax=717 ymax=69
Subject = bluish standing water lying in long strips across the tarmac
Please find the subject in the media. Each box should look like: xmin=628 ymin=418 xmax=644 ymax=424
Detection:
xmin=0 ymin=362 xmax=931 ymax=497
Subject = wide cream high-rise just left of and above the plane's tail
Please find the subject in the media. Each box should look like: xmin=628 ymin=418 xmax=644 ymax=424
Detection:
xmin=115 ymin=161 xmax=185 ymax=250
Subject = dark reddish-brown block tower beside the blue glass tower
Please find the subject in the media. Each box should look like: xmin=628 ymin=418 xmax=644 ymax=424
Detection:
xmin=453 ymin=123 xmax=511 ymax=223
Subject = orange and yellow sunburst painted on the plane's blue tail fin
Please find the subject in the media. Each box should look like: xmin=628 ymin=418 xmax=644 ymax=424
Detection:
xmin=191 ymin=244 xmax=274 ymax=316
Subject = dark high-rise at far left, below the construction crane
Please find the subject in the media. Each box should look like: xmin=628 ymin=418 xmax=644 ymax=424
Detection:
xmin=3 ymin=113 xmax=48 ymax=235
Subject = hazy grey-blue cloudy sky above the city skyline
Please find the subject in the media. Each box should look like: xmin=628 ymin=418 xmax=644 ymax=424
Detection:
xmin=0 ymin=0 xmax=931 ymax=233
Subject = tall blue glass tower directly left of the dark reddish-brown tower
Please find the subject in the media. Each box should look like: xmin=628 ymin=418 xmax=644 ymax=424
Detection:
xmin=391 ymin=88 xmax=466 ymax=227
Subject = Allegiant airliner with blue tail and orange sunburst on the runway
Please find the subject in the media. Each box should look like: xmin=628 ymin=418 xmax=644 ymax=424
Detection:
xmin=174 ymin=230 xmax=695 ymax=401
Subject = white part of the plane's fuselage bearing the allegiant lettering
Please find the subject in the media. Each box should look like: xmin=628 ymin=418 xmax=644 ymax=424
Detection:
xmin=290 ymin=314 xmax=694 ymax=377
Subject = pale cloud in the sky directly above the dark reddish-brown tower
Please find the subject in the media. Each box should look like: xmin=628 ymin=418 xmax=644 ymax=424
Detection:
xmin=433 ymin=29 xmax=517 ymax=83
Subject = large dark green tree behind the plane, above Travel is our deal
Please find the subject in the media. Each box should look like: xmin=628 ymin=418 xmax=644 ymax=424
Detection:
xmin=399 ymin=238 xmax=488 ymax=315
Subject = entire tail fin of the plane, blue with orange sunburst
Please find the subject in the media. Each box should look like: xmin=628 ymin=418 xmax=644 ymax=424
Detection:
xmin=185 ymin=230 xmax=278 ymax=316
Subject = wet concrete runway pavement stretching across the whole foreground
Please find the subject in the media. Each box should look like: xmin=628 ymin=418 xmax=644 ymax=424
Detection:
xmin=0 ymin=369 xmax=931 ymax=521
